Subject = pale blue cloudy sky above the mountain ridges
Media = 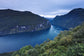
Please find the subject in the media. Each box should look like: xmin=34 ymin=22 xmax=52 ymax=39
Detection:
xmin=0 ymin=0 xmax=84 ymax=18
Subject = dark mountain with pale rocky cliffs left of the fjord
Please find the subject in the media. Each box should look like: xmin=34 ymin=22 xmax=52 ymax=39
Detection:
xmin=0 ymin=9 xmax=50 ymax=35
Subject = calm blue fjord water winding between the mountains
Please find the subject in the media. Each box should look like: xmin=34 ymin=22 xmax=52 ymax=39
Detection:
xmin=0 ymin=26 xmax=63 ymax=53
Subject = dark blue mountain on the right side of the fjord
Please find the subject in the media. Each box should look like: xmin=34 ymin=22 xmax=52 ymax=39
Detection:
xmin=52 ymin=8 xmax=84 ymax=29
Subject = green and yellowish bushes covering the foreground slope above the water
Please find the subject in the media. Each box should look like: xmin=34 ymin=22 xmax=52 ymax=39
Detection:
xmin=12 ymin=24 xmax=84 ymax=56
